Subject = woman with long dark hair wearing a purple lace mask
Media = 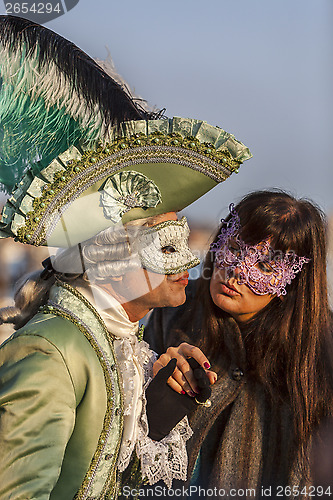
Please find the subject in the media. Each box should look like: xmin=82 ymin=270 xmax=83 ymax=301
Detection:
xmin=146 ymin=191 xmax=333 ymax=498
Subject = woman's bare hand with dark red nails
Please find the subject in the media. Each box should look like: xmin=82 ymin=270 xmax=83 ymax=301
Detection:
xmin=153 ymin=342 xmax=217 ymax=396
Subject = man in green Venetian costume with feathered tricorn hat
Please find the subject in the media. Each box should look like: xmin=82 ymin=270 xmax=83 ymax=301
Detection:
xmin=0 ymin=17 xmax=251 ymax=500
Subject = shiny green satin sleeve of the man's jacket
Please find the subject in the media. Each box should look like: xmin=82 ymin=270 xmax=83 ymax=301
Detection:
xmin=0 ymin=335 xmax=76 ymax=500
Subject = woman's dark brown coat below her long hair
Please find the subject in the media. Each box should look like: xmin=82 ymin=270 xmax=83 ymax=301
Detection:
xmin=145 ymin=287 xmax=312 ymax=499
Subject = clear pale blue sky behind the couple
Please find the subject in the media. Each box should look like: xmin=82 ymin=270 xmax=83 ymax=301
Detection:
xmin=0 ymin=0 xmax=333 ymax=223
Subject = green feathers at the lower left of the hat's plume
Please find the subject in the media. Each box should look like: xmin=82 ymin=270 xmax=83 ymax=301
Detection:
xmin=0 ymin=47 xmax=98 ymax=191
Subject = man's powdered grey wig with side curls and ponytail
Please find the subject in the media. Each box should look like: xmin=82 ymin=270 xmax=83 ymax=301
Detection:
xmin=0 ymin=217 xmax=156 ymax=330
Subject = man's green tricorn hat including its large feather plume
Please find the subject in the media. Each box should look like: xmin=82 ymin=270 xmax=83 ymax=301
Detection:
xmin=0 ymin=16 xmax=251 ymax=247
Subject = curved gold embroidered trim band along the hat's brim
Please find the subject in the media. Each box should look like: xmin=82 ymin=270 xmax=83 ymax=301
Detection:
xmin=17 ymin=132 xmax=241 ymax=245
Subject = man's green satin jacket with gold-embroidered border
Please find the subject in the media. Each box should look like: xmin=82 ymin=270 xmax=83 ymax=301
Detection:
xmin=0 ymin=284 xmax=123 ymax=500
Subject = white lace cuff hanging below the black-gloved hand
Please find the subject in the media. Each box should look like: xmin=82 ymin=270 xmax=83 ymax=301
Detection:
xmin=136 ymin=416 xmax=193 ymax=488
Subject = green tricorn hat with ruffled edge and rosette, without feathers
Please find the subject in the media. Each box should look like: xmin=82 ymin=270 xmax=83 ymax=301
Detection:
xmin=0 ymin=117 xmax=252 ymax=247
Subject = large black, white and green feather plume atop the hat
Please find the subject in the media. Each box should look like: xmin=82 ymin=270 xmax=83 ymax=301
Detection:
xmin=0 ymin=16 xmax=151 ymax=191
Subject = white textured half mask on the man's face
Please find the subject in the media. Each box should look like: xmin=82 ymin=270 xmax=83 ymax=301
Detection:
xmin=131 ymin=217 xmax=200 ymax=274
